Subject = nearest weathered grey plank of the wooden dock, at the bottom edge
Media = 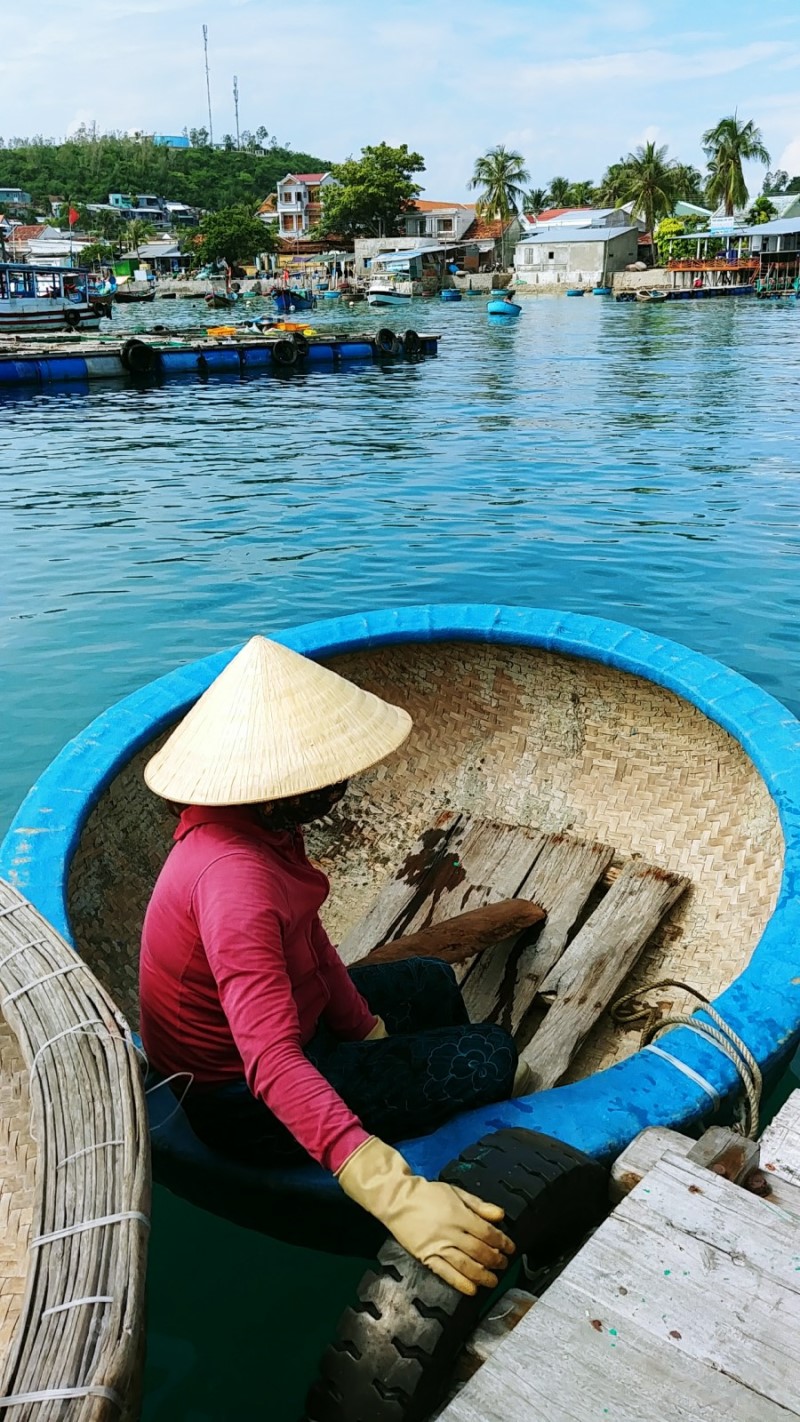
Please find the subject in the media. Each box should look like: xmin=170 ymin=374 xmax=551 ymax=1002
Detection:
xmin=440 ymin=1270 xmax=799 ymax=1422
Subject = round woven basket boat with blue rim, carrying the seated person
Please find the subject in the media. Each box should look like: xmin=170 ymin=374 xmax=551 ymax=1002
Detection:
xmin=0 ymin=606 xmax=800 ymax=1251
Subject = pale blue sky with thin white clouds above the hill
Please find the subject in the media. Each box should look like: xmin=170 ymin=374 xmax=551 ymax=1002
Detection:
xmin=0 ymin=0 xmax=800 ymax=201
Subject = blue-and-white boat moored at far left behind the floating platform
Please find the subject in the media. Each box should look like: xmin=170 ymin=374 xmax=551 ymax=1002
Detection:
xmin=0 ymin=262 xmax=111 ymax=336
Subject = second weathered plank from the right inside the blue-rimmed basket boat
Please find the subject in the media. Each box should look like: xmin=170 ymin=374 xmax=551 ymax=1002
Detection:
xmin=462 ymin=835 xmax=614 ymax=1035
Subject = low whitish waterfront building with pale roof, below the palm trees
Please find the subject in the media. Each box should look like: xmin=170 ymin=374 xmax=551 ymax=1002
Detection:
xmin=514 ymin=223 xmax=639 ymax=287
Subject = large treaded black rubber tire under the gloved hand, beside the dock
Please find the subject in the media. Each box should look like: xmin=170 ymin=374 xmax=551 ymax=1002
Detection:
xmin=306 ymin=1129 xmax=608 ymax=1422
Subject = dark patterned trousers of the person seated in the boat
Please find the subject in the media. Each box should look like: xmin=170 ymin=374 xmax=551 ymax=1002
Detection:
xmin=183 ymin=958 xmax=517 ymax=1165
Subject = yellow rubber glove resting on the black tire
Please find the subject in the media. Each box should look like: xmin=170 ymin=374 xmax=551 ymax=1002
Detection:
xmin=337 ymin=1136 xmax=514 ymax=1294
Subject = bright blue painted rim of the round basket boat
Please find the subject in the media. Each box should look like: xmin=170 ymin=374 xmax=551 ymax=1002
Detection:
xmin=0 ymin=604 xmax=800 ymax=1189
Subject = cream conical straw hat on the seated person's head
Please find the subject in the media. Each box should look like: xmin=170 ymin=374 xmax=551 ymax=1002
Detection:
xmin=145 ymin=637 xmax=412 ymax=805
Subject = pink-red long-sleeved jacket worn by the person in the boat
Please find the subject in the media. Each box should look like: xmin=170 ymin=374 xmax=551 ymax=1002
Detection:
xmin=139 ymin=805 xmax=375 ymax=1170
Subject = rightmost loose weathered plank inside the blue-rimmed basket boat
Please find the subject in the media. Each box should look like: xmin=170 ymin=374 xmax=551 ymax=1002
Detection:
xmin=523 ymin=859 xmax=688 ymax=1091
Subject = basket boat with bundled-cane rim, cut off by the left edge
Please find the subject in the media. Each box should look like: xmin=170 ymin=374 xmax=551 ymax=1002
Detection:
xmin=0 ymin=880 xmax=151 ymax=1422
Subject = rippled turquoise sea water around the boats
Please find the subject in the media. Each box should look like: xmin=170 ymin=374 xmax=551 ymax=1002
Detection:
xmin=0 ymin=297 xmax=800 ymax=1422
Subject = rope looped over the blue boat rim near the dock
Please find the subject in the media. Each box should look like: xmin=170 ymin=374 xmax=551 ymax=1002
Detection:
xmin=611 ymin=978 xmax=763 ymax=1140
